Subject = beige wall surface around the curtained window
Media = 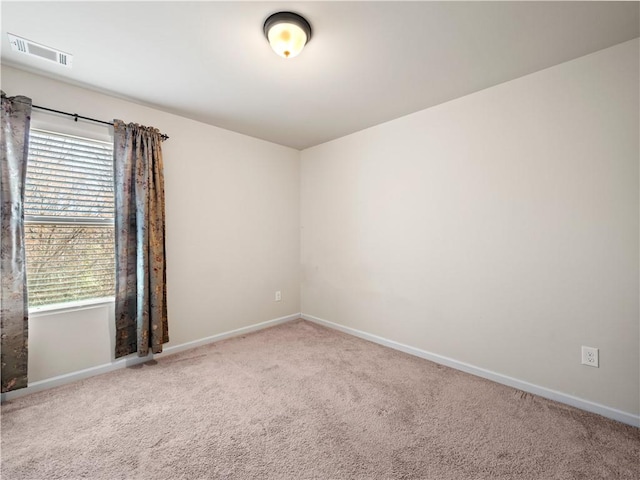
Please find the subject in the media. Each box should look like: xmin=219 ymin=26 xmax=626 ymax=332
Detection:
xmin=2 ymin=67 xmax=300 ymax=383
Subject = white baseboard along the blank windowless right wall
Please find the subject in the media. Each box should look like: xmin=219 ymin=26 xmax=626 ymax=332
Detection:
xmin=301 ymin=313 xmax=640 ymax=427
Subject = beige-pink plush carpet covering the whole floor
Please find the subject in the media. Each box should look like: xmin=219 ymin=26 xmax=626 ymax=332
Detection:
xmin=2 ymin=320 xmax=640 ymax=480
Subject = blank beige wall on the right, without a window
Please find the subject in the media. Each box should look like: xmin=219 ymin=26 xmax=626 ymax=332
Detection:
xmin=301 ymin=39 xmax=640 ymax=415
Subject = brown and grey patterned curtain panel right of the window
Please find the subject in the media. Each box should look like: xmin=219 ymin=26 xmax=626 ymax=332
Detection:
xmin=113 ymin=120 xmax=169 ymax=358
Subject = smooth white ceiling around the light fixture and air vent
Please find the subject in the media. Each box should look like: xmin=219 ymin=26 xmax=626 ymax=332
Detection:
xmin=1 ymin=1 xmax=640 ymax=149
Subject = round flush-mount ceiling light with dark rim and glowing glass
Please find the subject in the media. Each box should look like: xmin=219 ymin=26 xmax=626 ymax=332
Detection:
xmin=264 ymin=12 xmax=311 ymax=58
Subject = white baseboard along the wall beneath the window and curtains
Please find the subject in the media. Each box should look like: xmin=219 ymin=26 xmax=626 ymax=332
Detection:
xmin=0 ymin=313 xmax=301 ymax=402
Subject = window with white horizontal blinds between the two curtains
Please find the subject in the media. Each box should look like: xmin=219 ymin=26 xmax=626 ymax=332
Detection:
xmin=24 ymin=129 xmax=115 ymax=307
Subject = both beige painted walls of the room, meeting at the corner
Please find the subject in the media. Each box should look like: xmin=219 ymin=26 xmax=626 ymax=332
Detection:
xmin=2 ymin=40 xmax=640 ymax=415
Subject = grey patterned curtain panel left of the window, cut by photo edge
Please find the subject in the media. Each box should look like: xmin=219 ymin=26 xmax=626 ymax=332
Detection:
xmin=0 ymin=92 xmax=31 ymax=392
